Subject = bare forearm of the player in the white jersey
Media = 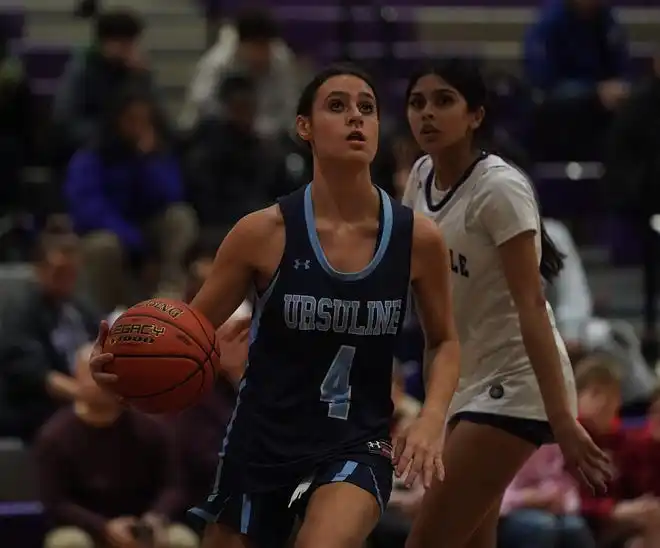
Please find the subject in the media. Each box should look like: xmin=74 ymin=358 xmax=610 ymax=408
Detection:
xmin=518 ymin=303 xmax=572 ymax=423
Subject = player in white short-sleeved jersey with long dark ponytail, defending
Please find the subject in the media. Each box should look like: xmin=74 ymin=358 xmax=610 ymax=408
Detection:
xmin=398 ymin=60 xmax=611 ymax=548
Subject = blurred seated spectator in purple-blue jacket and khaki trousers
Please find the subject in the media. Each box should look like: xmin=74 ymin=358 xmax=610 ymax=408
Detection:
xmin=65 ymin=89 xmax=197 ymax=312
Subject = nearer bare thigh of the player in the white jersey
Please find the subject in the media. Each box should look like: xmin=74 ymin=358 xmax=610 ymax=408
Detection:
xmin=406 ymin=421 xmax=536 ymax=548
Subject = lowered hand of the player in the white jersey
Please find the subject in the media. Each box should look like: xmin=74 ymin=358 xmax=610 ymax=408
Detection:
xmin=552 ymin=417 xmax=614 ymax=493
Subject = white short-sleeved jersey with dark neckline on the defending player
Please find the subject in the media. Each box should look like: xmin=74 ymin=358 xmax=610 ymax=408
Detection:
xmin=403 ymin=154 xmax=577 ymax=420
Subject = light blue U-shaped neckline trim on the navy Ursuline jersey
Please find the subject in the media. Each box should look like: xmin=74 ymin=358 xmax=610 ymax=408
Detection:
xmin=305 ymin=184 xmax=393 ymax=282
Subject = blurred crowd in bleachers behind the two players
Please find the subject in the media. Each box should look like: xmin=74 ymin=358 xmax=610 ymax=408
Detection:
xmin=0 ymin=0 xmax=660 ymax=548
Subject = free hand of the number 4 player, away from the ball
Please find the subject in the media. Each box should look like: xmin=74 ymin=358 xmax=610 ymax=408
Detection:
xmin=392 ymin=415 xmax=445 ymax=489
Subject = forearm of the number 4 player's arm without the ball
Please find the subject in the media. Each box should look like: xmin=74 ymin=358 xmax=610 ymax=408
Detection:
xmin=421 ymin=340 xmax=460 ymax=421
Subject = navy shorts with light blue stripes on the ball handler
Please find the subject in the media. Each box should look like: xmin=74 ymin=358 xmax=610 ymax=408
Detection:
xmin=189 ymin=456 xmax=393 ymax=548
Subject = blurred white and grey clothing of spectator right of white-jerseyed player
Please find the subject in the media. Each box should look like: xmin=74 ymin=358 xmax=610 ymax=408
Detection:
xmin=545 ymin=219 xmax=656 ymax=406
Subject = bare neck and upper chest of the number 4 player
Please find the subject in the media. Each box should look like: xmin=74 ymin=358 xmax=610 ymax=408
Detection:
xmin=312 ymin=165 xmax=380 ymax=221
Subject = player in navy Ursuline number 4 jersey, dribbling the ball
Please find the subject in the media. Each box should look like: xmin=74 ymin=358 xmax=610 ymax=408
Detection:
xmin=93 ymin=67 xmax=459 ymax=548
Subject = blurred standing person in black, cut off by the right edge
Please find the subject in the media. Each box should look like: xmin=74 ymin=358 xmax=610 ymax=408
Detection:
xmin=605 ymin=46 xmax=660 ymax=362
